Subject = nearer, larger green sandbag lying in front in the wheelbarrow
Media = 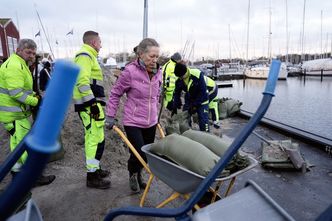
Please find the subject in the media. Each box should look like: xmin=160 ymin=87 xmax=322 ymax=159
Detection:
xmin=151 ymin=134 xmax=219 ymax=176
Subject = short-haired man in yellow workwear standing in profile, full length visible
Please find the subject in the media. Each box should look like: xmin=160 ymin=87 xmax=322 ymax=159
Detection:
xmin=73 ymin=31 xmax=111 ymax=189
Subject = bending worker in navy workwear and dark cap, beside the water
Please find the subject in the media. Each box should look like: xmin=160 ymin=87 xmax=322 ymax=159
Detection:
xmin=172 ymin=63 xmax=209 ymax=131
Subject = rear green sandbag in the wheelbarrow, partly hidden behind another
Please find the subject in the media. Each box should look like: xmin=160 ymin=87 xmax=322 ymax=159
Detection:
xmin=182 ymin=130 xmax=231 ymax=157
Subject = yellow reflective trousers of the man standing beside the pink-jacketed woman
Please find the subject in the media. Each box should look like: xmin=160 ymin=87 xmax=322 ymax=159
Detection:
xmin=78 ymin=103 xmax=105 ymax=172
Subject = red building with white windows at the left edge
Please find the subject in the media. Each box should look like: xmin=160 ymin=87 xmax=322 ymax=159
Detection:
xmin=0 ymin=18 xmax=20 ymax=60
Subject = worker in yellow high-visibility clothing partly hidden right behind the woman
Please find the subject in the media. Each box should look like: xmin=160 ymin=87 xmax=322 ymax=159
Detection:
xmin=162 ymin=52 xmax=182 ymax=111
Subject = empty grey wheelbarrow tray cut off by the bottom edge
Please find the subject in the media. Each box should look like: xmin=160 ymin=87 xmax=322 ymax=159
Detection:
xmin=192 ymin=180 xmax=295 ymax=221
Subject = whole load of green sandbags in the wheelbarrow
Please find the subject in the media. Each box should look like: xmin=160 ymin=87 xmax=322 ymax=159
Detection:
xmin=151 ymin=130 xmax=250 ymax=177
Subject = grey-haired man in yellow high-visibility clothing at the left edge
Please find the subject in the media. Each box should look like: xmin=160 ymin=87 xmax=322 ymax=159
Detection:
xmin=0 ymin=39 xmax=55 ymax=186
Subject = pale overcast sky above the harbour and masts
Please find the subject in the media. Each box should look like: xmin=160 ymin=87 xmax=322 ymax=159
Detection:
xmin=0 ymin=0 xmax=332 ymax=59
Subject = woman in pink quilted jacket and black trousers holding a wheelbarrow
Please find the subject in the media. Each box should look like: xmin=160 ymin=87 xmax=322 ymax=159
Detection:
xmin=106 ymin=38 xmax=162 ymax=192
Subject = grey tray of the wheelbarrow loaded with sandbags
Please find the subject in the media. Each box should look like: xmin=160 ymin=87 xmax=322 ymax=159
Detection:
xmin=142 ymin=144 xmax=258 ymax=194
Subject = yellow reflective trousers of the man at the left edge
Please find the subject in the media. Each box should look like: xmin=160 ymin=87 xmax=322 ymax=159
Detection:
xmin=4 ymin=118 xmax=31 ymax=172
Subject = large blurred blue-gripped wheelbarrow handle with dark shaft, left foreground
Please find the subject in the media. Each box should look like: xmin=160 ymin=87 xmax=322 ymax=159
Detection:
xmin=0 ymin=60 xmax=79 ymax=220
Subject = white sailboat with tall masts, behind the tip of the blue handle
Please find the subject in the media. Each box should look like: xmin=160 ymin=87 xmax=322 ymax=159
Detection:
xmin=244 ymin=0 xmax=288 ymax=80
